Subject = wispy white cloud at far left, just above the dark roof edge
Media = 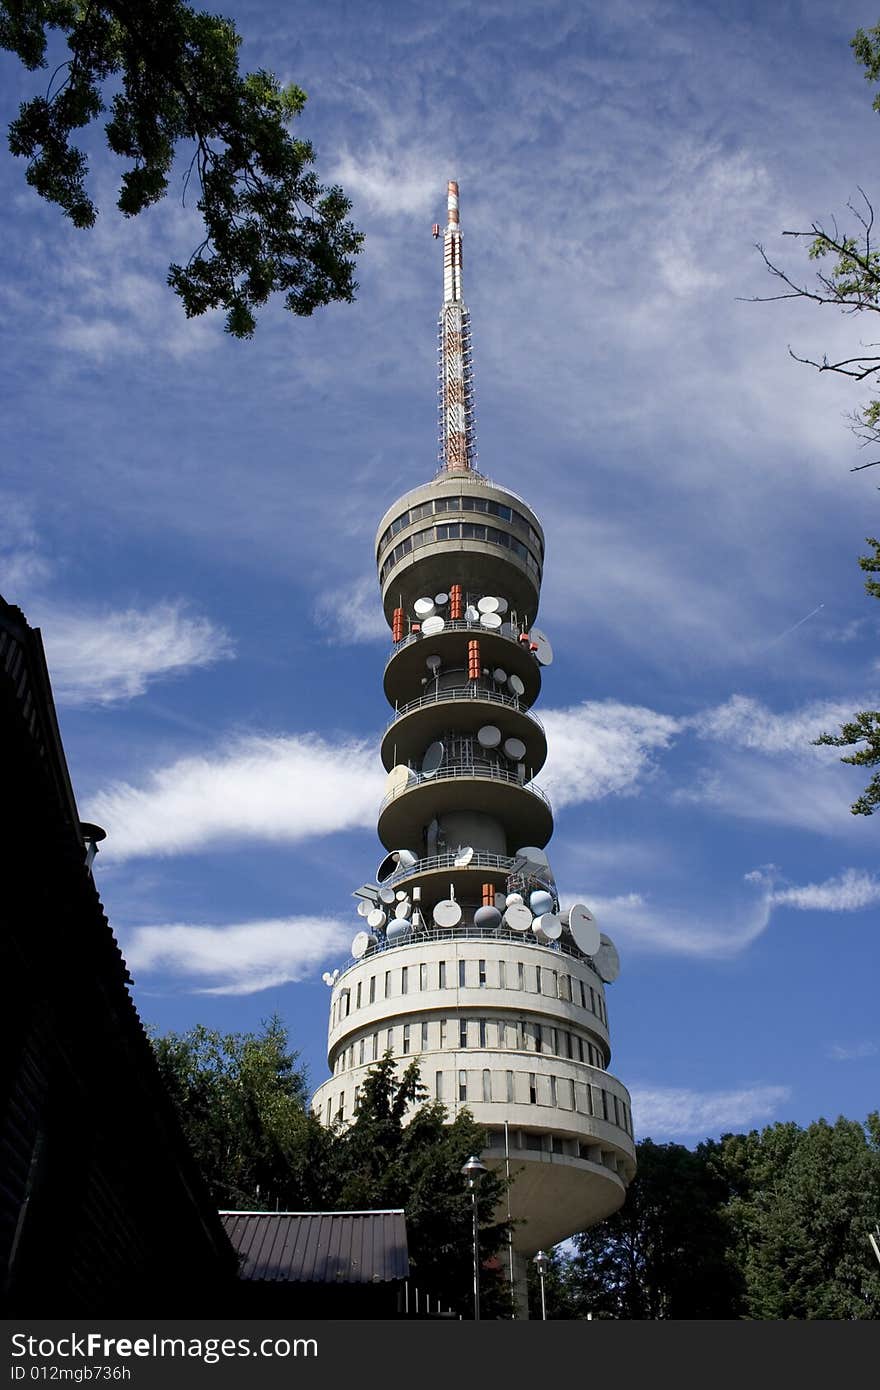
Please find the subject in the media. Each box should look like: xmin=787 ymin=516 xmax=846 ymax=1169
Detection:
xmin=36 ymin=602 xmax=232 ymax=705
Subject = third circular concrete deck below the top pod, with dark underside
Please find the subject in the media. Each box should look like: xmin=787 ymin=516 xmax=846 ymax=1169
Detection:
xmin=377 ymin=763 xmax=553 ymax=849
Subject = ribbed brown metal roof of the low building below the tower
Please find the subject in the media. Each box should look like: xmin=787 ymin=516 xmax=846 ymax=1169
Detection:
xmin=220 ymin=1211 xmax=409 ymax=1284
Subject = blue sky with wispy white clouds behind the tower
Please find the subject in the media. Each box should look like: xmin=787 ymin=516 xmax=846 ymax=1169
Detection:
xmin=0 ymin=0 xmax=880 ymax=1144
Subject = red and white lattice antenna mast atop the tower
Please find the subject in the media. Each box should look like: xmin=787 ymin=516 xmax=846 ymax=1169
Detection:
xmin=434 ymin=181 xmax=477 ymax=473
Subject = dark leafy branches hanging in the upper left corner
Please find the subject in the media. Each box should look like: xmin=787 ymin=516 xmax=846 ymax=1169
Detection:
xmin=0 ymin=0 xmax=363 ymax=338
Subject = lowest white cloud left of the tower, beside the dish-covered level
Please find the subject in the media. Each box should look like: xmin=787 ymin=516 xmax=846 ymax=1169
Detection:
xmin=122 ymin=917 xmax=352 ymax=994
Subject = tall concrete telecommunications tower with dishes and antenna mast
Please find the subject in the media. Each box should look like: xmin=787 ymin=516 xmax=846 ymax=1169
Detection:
xmin=313 ymin=183 xmax=635 ymax=1307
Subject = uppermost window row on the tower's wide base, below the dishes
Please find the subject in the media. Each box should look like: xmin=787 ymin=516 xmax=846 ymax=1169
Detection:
xmin=329 ymin=959 xmax=608 ymax=1029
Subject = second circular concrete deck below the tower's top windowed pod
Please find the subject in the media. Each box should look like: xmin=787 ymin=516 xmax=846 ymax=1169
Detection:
xmin=381 ymin=685 xmax=546 ymax=773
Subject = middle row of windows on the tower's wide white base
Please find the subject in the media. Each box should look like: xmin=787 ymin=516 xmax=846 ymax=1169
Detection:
xmin=334 ymin=1016 xmax=608 ymax=1076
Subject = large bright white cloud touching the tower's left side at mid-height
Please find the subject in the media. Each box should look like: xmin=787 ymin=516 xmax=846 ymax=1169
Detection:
xmin=86 ymin=735 xmax=382 ymax=862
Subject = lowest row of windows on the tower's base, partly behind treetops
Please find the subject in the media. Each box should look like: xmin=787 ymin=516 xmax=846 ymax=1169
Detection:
xmin=325 ymin=1068 xmax=634 ymax=1134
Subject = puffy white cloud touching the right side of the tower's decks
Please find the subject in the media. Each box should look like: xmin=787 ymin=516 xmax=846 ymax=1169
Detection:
xmin=541 ymin=701 xmax=680 ymax=808
